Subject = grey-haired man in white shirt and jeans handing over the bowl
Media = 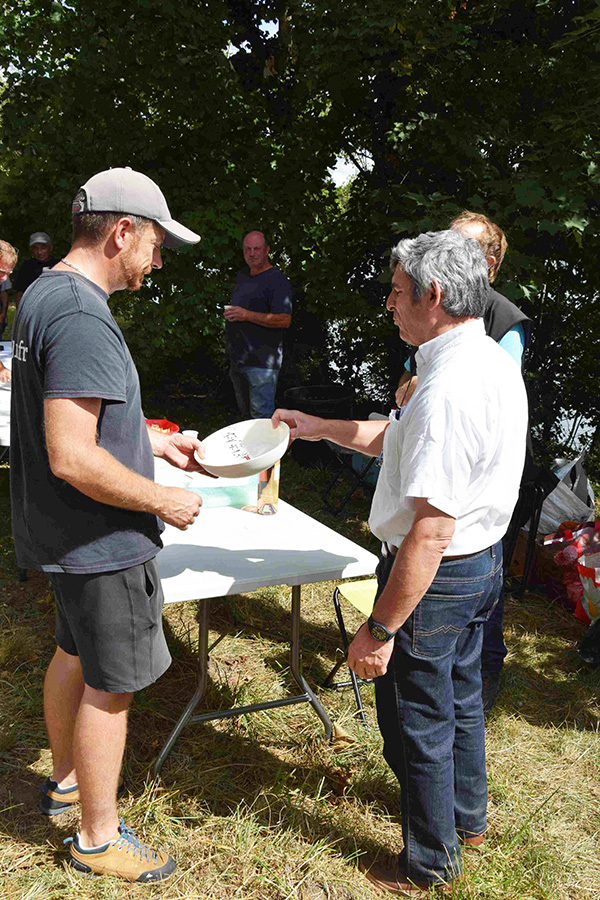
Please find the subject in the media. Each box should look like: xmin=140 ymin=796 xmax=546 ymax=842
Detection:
xmin=273 ymin=231 xmax=527 ymax=896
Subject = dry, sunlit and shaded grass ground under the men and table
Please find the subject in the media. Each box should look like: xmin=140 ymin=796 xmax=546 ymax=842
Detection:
xmin=0 ymin=391 xmax=600 ymax=900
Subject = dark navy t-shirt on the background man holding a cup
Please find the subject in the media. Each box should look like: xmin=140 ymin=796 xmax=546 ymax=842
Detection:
xmin=225 ymin=266 xmax=292 ymax=369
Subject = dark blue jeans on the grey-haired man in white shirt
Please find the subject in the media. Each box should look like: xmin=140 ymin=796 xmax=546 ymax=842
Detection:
xmin=375 ymin=543 xmax=502 ymax=883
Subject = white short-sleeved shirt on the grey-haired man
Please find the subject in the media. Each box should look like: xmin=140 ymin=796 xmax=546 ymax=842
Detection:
xmin=369 ymin=319 xmax=527 ymax=556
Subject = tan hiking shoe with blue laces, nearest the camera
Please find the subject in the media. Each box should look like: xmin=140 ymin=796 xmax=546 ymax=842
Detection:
xmin=65 ymin=819 xmax=177 ymax=884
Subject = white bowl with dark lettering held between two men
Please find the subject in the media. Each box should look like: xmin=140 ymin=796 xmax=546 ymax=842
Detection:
xmin=196 ymin=419 xmax=290 ymax=478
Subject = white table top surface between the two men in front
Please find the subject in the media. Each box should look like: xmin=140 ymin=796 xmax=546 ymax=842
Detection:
xmin=156 ymin=476 xmax=377 ymax=603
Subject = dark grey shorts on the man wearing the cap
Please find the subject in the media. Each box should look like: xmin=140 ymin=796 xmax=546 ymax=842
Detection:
xmin=48 ymin=559 xmax=171 ymax=693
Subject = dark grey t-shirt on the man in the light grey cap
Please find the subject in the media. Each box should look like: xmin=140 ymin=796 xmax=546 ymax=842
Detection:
xmin=10 ymin=271 xmax=162 ymax=575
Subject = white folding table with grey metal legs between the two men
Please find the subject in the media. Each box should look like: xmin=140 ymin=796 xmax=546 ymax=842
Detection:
xmin=153 ymin=470 xmax=377 ymax=776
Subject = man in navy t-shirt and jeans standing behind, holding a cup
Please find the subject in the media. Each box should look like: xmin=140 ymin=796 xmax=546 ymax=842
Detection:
xmin=225 ymin=231 xmax=292 ymax=419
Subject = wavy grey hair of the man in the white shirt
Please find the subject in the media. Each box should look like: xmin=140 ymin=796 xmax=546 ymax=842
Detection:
xmin=390 ymin=230 xmax=489 ymax=318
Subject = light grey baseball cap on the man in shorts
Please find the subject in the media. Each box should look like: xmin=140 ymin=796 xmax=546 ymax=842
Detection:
xmin=73 ymin=166 xmax=200 ymax=247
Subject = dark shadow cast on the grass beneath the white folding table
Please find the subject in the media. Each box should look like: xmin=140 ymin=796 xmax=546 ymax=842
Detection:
xmin=127 ymin=652 xmax=399 ymax=856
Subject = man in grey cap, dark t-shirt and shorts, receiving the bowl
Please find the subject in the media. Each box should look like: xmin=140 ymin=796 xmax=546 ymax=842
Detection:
xmin=11 ymin=169 xmax=204 ymax=882
